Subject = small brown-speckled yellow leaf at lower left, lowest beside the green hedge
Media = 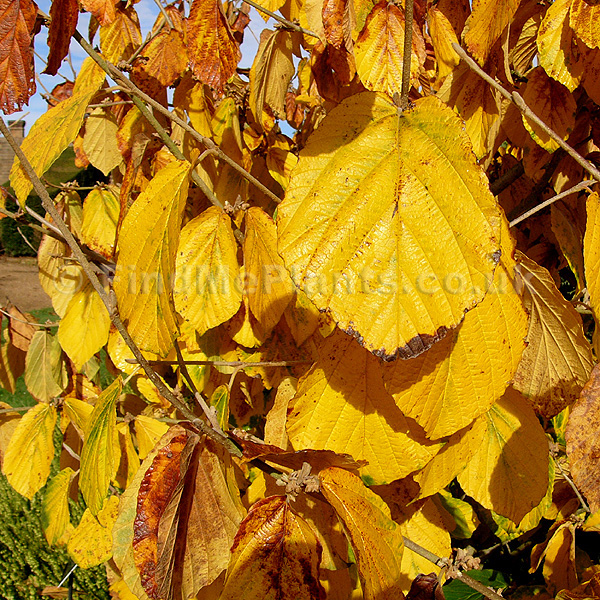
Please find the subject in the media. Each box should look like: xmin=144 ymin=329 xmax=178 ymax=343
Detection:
xmin=67 ymin=496 xmax=119 ymax=569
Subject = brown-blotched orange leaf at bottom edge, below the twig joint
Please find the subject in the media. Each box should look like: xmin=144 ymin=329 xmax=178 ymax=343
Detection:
xmin=220 ymin=496 xmax=325 ymax=600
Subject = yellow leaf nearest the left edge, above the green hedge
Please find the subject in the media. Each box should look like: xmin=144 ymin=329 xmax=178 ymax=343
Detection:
xmin=2 ymin=402 xmax=57 ymax=500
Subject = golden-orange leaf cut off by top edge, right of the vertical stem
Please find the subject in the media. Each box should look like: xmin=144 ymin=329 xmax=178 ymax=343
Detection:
xmin=462 ymin=0 xmax=520 ymax=66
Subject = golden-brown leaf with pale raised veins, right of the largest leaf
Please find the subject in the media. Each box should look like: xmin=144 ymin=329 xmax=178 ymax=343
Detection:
xmin=514 ymin=253 xmax=593 ymax=418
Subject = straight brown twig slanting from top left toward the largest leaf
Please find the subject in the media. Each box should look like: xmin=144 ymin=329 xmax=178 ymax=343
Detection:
xmin=73 ymin=31 xmax=281 ymax=203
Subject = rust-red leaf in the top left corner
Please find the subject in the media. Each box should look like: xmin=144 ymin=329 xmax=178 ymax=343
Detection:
xmin=0 ymin=0 xmax=37 ymax=114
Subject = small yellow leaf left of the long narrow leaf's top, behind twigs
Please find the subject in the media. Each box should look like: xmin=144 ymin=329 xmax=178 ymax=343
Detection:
xmin=81 ymin=188 xmax=120 ymax=259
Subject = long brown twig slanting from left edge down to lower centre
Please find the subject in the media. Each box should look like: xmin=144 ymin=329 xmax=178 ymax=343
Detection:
xmin=0 ymin=117 xmax=241 ymax=456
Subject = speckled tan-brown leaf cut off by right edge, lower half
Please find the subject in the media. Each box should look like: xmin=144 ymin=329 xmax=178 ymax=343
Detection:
xmin=565 ymin=365 xmax=600 ymax=512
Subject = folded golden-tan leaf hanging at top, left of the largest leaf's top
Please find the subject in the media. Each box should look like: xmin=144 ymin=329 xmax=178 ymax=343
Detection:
xmin=250 ymin=29 xmax=295 ymax=123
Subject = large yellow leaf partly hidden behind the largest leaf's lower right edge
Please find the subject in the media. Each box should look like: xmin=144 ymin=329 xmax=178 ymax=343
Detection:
xmin=385 ymin=255 xmax=527 ymax=439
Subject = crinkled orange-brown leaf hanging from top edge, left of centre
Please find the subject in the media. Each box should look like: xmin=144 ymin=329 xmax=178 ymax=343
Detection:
xmin=187 ymin=0 xmax=241 ymax=92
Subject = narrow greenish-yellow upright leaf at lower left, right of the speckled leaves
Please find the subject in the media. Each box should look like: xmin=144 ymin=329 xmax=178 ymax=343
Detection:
xmin=79 ymin=378 xmax=123 ymax=514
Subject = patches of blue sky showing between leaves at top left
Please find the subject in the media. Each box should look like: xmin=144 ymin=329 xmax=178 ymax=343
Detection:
xmin=11 ymin=0 xmax=264 ymax=132
